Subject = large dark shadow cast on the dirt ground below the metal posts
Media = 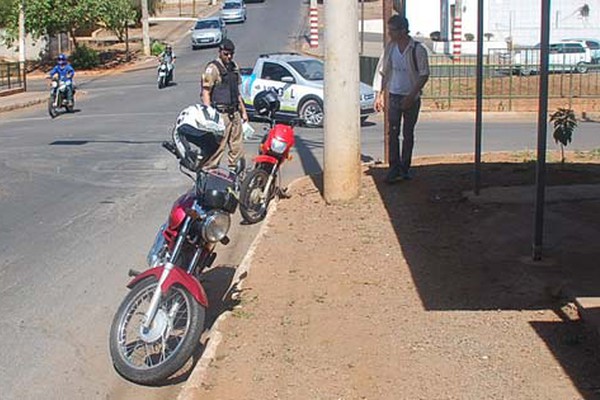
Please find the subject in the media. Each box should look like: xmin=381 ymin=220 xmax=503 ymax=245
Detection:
xmin=367 ymin=162 xmax=600 ymax=398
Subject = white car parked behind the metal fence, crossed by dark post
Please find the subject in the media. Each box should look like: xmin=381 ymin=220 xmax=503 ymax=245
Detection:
xmin=498 ymin=41 xmax=595 ymax=76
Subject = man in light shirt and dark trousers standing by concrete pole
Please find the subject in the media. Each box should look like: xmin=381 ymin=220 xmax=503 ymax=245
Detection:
xmin=373 ymin=15 xmax=429 ymax=183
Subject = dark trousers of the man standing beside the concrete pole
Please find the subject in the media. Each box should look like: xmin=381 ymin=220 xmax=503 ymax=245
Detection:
xmin=388 ymin=94 xmax=421 ymax=174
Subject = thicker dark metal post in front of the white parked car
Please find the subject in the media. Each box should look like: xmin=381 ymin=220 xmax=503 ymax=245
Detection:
xmin=533 ymin=0 xmax=550 ymax=261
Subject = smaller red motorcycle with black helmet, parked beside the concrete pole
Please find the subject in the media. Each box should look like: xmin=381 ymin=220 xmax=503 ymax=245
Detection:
xmin=240 ymin=90 xmax=300 ymax=224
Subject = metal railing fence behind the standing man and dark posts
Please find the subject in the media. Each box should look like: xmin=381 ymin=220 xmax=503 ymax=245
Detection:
xmin=360 ymin=51 xmax=600 ymax=111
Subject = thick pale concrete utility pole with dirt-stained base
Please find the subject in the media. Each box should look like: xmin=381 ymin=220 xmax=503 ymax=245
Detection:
xmin=323 ymin=0 xmax=361 ymax=203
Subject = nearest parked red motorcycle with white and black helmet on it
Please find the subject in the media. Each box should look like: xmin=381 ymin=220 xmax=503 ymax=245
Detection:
xmin=109 ymin=105 xmax=238 ymax=384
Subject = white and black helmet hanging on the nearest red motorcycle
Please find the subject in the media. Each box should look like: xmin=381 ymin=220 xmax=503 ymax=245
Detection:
xmin=173 ymin=104 xmax=225 ymax=171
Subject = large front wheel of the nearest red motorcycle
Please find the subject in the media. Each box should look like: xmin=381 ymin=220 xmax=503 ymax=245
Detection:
xmin=109 ymin=278 xmax=206 ymax=385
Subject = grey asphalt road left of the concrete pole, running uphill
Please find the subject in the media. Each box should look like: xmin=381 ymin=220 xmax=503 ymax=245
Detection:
xmin=0 ymin=0 xmax=304 ymax=399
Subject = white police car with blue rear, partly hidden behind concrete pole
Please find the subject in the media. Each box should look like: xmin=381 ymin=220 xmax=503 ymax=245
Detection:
xmin=240 ymin=53 xmax=375 ymax=127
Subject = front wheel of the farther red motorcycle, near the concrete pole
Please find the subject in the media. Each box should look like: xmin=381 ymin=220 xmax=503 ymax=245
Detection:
xmin=240 ymin=168 xmax=274 ymax=224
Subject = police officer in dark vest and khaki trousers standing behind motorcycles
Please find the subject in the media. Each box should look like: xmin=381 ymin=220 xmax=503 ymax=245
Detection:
xmin=202 ymin=39 xmax=248 ymax=169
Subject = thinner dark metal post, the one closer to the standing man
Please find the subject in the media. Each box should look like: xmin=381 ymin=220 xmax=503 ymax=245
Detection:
xmin=474 ymin=0 xmax=483 ymax=195
